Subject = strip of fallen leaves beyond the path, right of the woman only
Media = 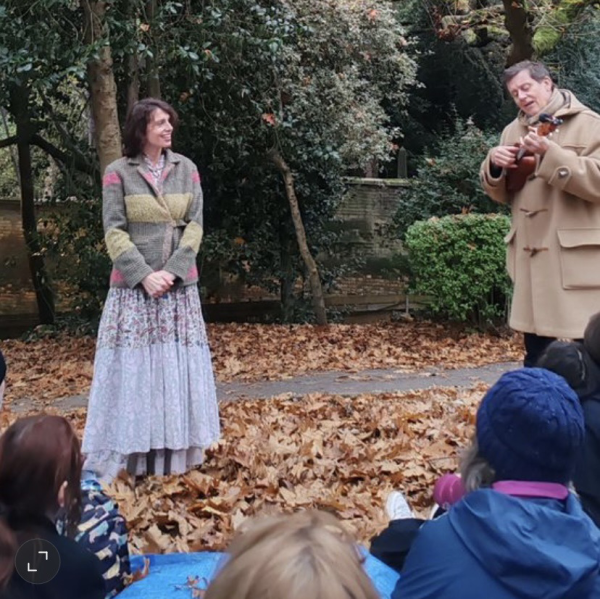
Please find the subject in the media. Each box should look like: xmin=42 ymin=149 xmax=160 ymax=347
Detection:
xmin=209 ymin=322 xmax=522 ymax=381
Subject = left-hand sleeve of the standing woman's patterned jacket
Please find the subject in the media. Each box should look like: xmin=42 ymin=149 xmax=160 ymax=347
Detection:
xmin=102 ymin=165 xmax=154 ymax=289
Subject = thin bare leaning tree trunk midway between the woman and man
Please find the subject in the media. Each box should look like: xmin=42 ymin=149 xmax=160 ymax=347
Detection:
xmin=269 ymin=150 xmax=327 ymax=324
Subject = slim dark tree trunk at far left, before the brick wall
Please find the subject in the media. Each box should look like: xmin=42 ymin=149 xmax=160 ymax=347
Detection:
xmin=10 ymin=87 xmax=55 ymax=324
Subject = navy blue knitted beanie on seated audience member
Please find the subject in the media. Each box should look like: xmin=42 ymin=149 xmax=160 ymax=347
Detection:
xmin=476 ymin=368 xmax=584 ymax=484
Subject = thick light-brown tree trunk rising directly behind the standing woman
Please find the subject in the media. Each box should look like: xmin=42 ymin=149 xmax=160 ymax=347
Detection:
xmin=81 ymin=0 xmax=122 ymax=173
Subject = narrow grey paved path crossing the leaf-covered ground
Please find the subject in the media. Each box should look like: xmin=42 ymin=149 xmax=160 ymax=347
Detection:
xmin=11 ymin=362 xmax=520 ymax=412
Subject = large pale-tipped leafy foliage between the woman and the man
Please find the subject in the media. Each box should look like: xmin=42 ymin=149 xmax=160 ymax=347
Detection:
xmin=157 ymin=0 xmax=415 ymax=324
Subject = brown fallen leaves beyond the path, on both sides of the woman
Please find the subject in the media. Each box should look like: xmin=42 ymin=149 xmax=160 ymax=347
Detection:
xmin=0 ymin=322 xmax=522 ymax=405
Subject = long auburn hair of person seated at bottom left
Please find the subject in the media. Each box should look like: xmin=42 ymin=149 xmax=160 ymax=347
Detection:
xmin=0 ymin=414 xmax=82 ymax=588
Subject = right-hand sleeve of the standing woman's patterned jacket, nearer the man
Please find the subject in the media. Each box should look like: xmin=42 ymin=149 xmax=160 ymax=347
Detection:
xmin=164 ymin=166 xmax=204 ymax=280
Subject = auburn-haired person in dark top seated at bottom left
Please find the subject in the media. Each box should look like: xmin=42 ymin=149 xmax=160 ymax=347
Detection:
xmin=0 ymin=414 xmax=105 ymax=599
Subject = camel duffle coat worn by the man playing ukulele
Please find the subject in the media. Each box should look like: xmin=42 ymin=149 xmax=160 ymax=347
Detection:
xmin=480 ymin=90 xmax=600 ymax=339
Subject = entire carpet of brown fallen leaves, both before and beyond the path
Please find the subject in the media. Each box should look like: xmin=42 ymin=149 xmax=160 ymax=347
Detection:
xmin=1 ymin=323 xmax=506 ymax=553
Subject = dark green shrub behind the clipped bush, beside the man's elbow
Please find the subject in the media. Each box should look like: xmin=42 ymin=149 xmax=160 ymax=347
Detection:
xmin=395 ymin=119 xmax=505 ymax=236
